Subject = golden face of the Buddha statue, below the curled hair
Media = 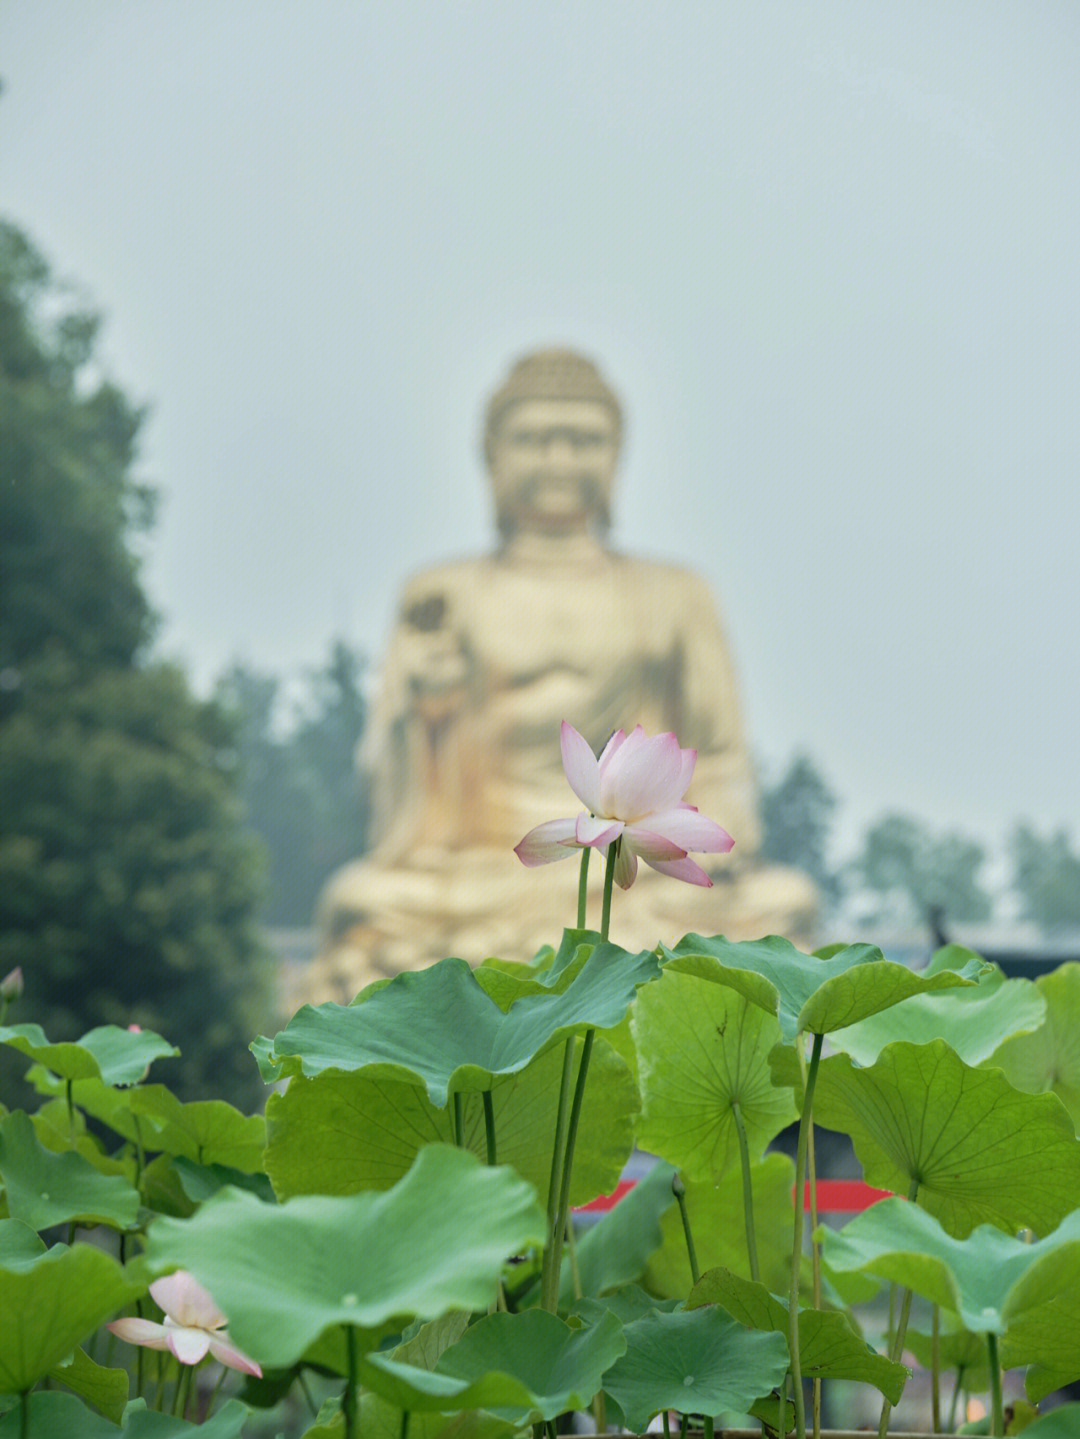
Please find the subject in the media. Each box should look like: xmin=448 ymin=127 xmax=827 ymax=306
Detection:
xmin=490 ymin=400 xmax=618 ymax=534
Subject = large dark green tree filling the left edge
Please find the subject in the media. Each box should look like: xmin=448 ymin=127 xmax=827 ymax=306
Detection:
xmin=0 ymin=224 xmax=272 ymax=1102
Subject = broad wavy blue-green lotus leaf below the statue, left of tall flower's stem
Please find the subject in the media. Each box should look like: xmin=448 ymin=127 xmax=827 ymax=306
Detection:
xmin=272 ymin=947 xmax=659 ymax=1108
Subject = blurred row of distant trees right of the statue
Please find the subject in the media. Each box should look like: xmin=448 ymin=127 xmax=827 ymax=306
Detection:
xmin=762 ymin=754 xmax=1080 ymax=937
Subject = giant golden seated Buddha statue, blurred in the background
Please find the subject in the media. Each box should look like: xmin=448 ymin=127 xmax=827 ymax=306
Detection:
xmin=305 ymin=350 xmax=817 ymax=1000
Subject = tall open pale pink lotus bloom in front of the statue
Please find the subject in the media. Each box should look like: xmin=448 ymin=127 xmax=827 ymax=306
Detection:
xmin=513 ymin=720 xmax=735 ymax=889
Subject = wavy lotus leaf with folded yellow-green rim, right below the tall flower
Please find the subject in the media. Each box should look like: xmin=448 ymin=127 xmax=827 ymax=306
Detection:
xmin=662 ymin=934 xmax=982 ymax=1042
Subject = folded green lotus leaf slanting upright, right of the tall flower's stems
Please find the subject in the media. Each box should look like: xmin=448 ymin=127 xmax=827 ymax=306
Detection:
xmin=559 ymin=1160 xmax=682 ymax=1308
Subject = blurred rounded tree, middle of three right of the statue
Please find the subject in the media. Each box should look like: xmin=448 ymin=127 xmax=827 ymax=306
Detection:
xmin=851 ymin=814 xmax=994 ymax=924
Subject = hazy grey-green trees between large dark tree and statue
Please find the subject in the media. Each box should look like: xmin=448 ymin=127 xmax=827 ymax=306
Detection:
xmin=217 ymin=640 xmax=367 ymax=925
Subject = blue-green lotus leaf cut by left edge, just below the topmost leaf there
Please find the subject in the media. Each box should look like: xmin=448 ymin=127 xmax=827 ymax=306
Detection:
xmin=0 ymin=1109 xmax=139 ymax=1229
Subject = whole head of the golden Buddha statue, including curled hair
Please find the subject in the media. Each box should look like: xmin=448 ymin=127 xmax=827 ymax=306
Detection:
xmin=485 ymin=350 xmax=623 ymax=540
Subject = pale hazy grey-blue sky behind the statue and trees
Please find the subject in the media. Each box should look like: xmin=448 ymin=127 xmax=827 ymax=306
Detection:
xmin=0 ymin=0 xmax=1080 ymax=840
